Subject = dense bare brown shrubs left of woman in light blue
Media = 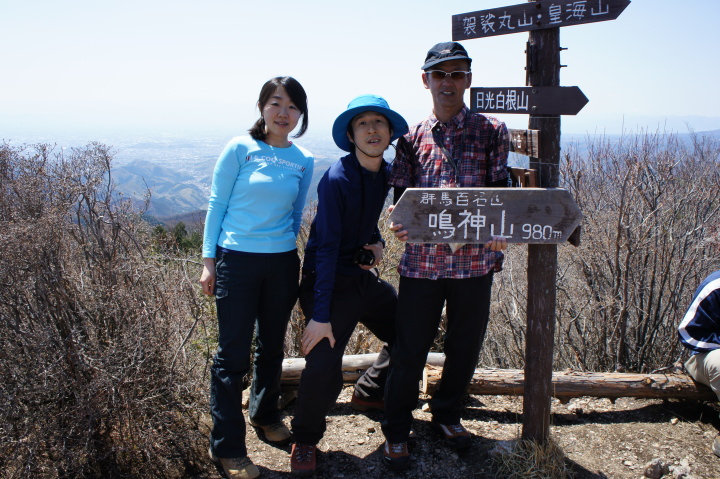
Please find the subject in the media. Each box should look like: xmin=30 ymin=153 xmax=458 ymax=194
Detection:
xmin=0 ymin=143 xmax=209 ymax=478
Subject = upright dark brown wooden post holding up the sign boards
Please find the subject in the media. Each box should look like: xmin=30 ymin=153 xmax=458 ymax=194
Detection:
xmin=522 ymin=20 xmax=560 ymax=444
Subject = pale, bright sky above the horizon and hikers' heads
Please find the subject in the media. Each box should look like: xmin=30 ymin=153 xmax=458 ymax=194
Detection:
xmin=0 ymin=0 xmax=720 ymax=139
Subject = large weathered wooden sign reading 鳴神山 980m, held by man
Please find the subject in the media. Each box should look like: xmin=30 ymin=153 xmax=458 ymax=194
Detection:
xmin=390 ymin=188 xmax=582 ymax=244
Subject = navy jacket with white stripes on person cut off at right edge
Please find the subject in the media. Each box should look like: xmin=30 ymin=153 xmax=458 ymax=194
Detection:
xmin=678 ymin=271 xmax=720 ymax=354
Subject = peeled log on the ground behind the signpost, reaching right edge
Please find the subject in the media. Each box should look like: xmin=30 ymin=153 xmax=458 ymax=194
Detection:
xmin=421 ymin=365 xmax=717 ymax=402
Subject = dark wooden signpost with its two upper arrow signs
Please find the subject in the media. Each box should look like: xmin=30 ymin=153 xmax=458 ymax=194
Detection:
xmin=442 ymin=0 xmax=630 ymax=443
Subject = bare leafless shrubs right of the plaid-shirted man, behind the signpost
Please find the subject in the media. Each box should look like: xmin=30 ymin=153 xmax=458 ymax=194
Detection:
xmin=482 ymin=134 xmax=720 ymax=372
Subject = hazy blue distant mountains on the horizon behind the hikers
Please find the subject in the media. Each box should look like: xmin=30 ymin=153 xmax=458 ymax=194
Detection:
xmin=112 ymin=130 xmax=720 ymax=227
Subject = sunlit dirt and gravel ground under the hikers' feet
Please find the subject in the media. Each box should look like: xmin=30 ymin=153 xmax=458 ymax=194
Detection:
xmin=198 ymin=387 xmax=720 ymax=479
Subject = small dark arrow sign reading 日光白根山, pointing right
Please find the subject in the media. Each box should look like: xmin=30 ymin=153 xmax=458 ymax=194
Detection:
xmin=470 ymin=86 xmax=588 ymax=115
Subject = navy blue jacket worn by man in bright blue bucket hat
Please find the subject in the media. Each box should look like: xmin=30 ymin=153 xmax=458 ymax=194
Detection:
xmin=303 ymin=153 xmax=390 ymax=323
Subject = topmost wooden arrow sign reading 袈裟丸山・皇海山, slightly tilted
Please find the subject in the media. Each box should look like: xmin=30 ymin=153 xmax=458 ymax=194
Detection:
xmin=452 ymin=0 xmax=630 ymax=41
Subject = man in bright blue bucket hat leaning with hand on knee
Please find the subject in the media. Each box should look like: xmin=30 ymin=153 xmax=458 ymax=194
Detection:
xmin=290 ymin=95 xmax=408 ymax=475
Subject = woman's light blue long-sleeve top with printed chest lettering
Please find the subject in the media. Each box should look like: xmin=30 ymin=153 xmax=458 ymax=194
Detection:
xmin=202 ymin=136 xmax=314 ymax=258
